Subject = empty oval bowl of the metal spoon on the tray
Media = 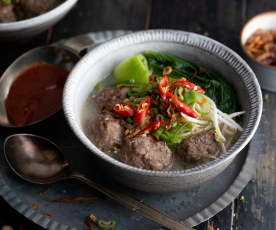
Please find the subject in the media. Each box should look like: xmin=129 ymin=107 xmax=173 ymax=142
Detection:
xmin=4 ymin=134 xmax=71 ymax=184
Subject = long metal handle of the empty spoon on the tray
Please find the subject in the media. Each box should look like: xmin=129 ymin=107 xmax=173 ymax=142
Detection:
xmin=71 ymin=173 xmax=194 ymax=230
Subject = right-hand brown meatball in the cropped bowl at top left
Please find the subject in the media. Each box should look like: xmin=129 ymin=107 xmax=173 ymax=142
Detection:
xmin=19 ymin=0 xmax=53 ymax=18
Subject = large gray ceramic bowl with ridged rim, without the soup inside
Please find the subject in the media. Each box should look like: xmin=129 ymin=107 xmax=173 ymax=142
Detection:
xmin=63 ymin=30 xmax=262 ymax=192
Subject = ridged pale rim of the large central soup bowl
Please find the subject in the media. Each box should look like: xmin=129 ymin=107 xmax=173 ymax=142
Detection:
xmin=63 ymin=29 xmax=263 ymax=177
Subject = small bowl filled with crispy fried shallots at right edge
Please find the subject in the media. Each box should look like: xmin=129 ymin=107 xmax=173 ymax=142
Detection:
xmin=240 ymin=11 xmax=276 ymax=92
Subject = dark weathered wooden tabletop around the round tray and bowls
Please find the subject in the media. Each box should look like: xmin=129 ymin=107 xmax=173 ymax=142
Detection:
xmin=0 ymin=0 xmax=276 ymax=230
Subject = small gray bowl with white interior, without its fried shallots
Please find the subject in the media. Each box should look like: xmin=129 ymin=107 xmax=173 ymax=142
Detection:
xmin=240 ymin=11 xmax=276 ymax=92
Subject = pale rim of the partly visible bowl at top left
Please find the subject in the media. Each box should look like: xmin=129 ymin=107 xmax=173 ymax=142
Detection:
xmin=0 ymin=0 xmax=78 ymax=29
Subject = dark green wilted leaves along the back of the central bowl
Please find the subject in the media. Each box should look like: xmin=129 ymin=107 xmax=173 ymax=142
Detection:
xmin=144 ymin=51 xmax=238 ymax=113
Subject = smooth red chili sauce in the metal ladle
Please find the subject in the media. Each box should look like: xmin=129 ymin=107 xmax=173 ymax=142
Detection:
xmin=5 ymin=62 xmax=69 ymax=126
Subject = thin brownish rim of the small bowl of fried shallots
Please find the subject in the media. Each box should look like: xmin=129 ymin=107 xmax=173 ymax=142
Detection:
xmin=240 ymin=10 xmax=276 ymax=70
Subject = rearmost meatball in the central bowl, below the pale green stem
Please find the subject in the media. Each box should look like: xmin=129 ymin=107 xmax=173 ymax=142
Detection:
xmin=94 ymin=87 xmax=129 ymax=109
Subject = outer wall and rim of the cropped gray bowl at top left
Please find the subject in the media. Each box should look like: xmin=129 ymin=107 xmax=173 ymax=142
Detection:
xmin=0 ymin=0 xmax=78 ymax=41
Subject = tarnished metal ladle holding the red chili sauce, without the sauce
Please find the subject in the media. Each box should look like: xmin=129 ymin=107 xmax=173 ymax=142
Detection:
xmin=0 ymin=35 xmax=94 ymax=127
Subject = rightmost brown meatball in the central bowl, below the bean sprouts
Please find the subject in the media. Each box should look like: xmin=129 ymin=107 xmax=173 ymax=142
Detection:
xmin=177 ymin=131 xmax=222 ymax=163
